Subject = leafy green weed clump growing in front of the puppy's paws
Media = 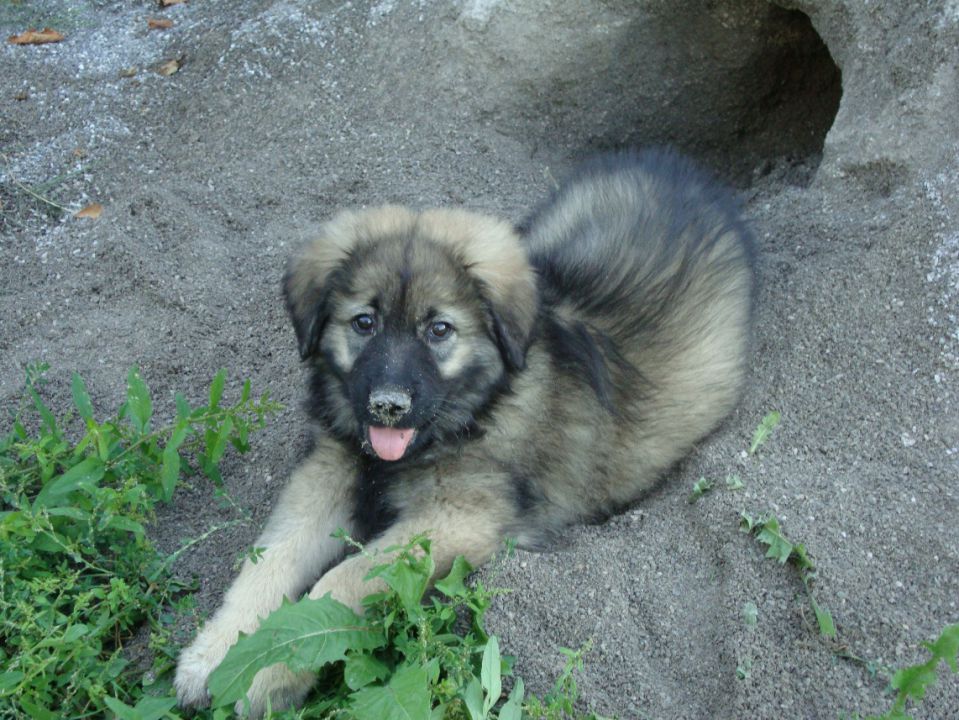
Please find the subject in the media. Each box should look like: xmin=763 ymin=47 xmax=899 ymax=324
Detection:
xmin=210 ymin=536 xmax=612 ymax=720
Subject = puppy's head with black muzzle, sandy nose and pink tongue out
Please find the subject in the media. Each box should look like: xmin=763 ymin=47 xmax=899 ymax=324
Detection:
xmin=284 ymin=206 xmax=538 ymax=461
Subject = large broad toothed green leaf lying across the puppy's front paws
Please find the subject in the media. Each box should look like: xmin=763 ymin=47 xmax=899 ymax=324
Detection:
xmin=209 ymin=594 xmax=384 ymax=707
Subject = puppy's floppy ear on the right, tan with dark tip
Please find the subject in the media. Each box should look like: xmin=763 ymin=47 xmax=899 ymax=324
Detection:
xmin=418 ymin=210 xmax=539 ymax=370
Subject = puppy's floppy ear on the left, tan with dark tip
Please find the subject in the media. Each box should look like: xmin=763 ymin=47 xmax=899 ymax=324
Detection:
xmin=283 ymin=205 xmax=413 ymax=360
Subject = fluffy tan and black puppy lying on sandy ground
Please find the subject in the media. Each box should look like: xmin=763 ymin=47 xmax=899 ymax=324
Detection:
xmin=175 ymin=151 xmax=755 ymax=716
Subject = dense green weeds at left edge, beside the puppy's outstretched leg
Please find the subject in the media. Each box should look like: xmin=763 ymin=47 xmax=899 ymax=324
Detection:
xmin=0 ymin=365 xmax=278 ymax=720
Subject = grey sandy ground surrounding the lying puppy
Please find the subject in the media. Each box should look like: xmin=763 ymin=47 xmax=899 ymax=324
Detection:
xmin=0 ymin=0 xmax=959 ymax=719
